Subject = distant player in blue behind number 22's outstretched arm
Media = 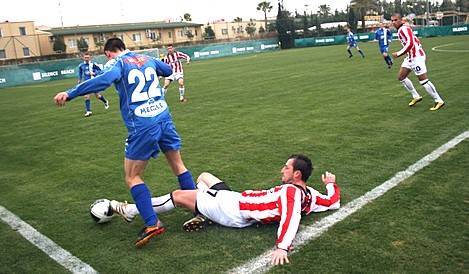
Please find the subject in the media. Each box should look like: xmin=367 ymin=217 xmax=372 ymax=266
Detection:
xmin=78 ymin=53 xmax=109 ymax=117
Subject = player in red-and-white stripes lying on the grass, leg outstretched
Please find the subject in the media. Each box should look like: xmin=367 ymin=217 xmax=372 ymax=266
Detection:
xmin=111 ymin=154 xmax=340 ymax=265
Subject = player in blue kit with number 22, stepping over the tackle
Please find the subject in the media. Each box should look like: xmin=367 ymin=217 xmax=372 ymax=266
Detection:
xmin=54 ymin=38 xmax=196 ymax=247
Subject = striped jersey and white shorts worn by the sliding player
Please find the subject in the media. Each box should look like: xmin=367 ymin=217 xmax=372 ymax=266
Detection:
xmin=197 ymin=183 xmax=340 ymax=250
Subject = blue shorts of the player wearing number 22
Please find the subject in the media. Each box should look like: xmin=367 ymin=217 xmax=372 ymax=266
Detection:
xmin=125 ymin=120 xmax=181 ymax=161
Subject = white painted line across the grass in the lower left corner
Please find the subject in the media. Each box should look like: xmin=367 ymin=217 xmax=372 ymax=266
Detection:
xmin=0 ymin=205 xmax=98 ymax=274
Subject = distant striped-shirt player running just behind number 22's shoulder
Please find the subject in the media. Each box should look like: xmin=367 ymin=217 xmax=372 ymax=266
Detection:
xmin=163 ymin=45 xmax=191 ymax=103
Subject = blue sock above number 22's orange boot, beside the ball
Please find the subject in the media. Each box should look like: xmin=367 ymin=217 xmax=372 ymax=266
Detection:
xmin=130 ymin=183 xmax=158 ymax=226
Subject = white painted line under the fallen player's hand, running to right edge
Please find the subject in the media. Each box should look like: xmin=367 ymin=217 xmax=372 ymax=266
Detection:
xmin=228 ymin=130 xmax=469 ymax=273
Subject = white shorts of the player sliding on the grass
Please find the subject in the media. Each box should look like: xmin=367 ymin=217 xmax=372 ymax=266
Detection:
xmin=197 ymin=189 xmax=256 ymax=228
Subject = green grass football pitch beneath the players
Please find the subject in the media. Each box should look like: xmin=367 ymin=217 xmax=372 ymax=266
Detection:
xmin=0 ymin=36 xmax=469 ymax=273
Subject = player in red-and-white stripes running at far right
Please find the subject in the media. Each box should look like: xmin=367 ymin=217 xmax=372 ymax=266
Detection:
xmin=391 ymin=13 xmax=445 ymax=110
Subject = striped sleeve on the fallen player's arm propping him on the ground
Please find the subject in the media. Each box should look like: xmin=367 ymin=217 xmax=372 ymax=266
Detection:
xmin=275 ymin=185 xmax=302 ymax=250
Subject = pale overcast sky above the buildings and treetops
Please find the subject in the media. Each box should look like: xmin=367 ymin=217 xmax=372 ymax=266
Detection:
xmin=0 ymin=0 xmax=350 ymax=27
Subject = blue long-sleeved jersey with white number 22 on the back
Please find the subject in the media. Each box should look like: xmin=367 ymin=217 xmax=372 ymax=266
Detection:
xmin=67 ymin=50 xmax=173 ymax=134
